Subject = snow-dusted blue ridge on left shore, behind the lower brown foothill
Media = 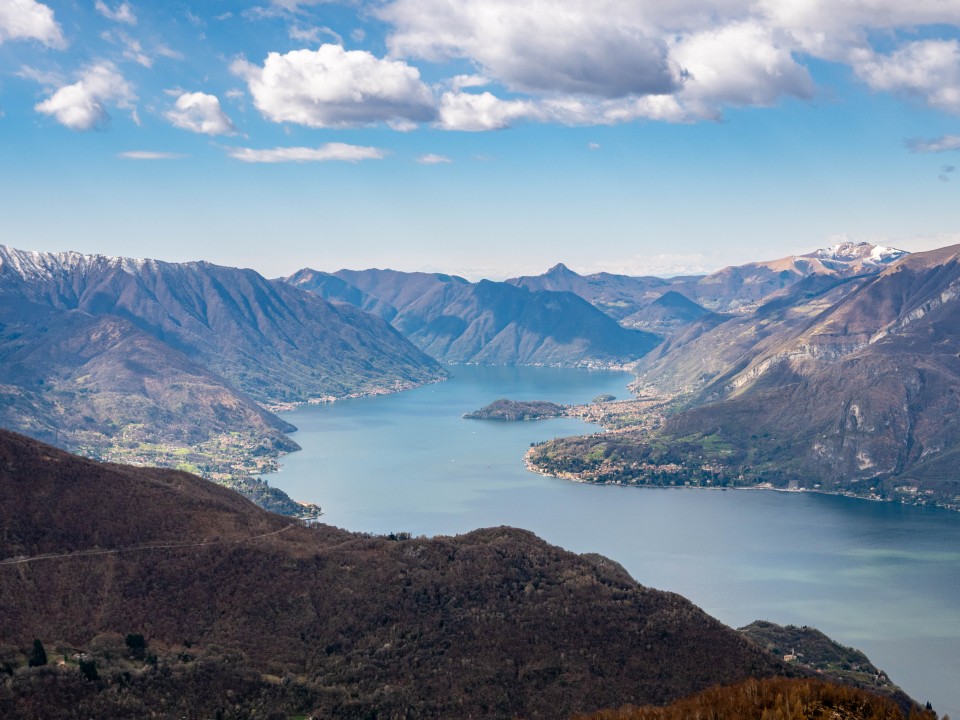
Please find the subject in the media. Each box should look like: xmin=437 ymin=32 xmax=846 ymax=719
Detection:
xmin=0 ymin=248 xmax=437 ymax=402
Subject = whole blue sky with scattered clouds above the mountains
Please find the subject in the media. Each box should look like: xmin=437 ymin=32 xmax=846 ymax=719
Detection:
xmin=0 ymin=0 xmax=960 ymax=278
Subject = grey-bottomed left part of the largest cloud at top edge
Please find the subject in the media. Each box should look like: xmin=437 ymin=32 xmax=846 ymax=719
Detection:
xmin=377 ymin=0 xmax=681 ymax=97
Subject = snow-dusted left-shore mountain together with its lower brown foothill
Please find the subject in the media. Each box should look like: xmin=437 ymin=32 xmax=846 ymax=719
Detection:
xmin=0 ymin=246 xmax=443 ymax=458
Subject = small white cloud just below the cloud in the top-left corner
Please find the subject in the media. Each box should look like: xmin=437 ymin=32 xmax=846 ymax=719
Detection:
xmin=35 ymin=62 xmax=136 ymax=130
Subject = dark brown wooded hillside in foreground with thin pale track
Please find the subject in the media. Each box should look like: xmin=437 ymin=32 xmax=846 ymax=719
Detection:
xmin=0 ymin=430 xmax=924 ymax=718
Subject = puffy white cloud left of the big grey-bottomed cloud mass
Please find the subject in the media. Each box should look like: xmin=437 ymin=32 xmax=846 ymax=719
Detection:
xmin=232 ymin=44 xmax=436 ymax=127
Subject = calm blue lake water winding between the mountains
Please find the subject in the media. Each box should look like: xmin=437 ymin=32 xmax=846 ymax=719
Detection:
xmin=269 ymin=366 xmax=960 ymax=719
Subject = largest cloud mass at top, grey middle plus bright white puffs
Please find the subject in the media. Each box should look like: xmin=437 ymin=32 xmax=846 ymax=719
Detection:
xmin=376 ymin=0 xmax=815 ymax=125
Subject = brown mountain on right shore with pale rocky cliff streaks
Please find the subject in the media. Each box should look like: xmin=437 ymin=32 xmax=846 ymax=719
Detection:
xmin=665 ymin=247 xmax=960 ymax=502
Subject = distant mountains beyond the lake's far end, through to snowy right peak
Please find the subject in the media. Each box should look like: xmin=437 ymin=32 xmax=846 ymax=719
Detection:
xmin=284 ymin=242 xmax=906 ymax=366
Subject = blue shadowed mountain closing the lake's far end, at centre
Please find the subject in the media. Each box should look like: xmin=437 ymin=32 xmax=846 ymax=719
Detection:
xmin=286 ymin=269 xmax=658 ymax=366
